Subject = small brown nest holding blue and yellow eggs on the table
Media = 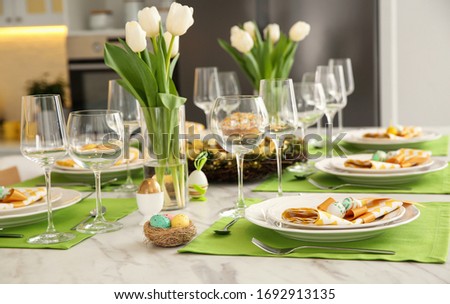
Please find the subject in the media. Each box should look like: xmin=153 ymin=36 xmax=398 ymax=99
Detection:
xmin=144 ymin=221 xmax=197 ymax=247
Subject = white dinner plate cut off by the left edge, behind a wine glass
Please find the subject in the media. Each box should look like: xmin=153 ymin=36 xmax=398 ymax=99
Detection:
xmin=0 ymin=188 xmax=81 ymax=228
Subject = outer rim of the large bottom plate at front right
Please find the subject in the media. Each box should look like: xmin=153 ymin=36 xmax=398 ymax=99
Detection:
xmin=245 ymin=194 xmax=420 ymax=235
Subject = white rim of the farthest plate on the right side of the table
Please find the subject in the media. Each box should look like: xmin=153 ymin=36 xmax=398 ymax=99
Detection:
xmin=344 ymin=128 xmax=442 ymax=146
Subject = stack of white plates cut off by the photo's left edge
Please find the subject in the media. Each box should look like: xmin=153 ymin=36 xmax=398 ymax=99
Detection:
xmin=0 ymin=188 xmax=81 ymax=228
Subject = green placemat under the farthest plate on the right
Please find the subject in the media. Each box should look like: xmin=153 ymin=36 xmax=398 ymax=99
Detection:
xmin=326 ymin=135 xmax=449 ymax=156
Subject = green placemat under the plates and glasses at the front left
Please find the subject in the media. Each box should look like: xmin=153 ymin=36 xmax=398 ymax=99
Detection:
xmin=0 ymin=198 xmax=137 ymax=249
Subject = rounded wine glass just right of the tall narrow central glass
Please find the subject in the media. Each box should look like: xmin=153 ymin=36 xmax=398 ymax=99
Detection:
xmin=294 ymin=82 xmax=325 ymax=173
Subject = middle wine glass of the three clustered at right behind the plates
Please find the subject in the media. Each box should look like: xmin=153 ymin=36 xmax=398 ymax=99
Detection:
xmin=316 ymin=65 xmax=347 ymax=157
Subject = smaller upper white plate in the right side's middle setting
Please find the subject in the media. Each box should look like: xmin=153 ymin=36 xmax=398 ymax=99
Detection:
xmin=331 ymin=154 xmax=434 ymax=174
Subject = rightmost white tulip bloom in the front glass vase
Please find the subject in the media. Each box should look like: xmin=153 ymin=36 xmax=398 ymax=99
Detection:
xmin=166 ymin=2 xmax=194 ymax=36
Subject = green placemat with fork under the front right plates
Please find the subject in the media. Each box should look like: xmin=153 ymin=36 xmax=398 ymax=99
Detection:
xmin=178 ymin=203 xmax=450 ymax=263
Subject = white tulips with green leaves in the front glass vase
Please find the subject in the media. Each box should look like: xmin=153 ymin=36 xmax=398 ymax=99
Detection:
xmin=104 ymin=2 xmax=194 ymax=207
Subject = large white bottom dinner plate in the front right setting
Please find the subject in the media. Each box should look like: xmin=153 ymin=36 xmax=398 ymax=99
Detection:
xmin=245 ymin=193 xmax=420 ymax=242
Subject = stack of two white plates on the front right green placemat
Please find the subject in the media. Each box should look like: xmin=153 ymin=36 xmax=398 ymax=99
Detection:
xmin=245 ymin=194 xmax=420 ymax=242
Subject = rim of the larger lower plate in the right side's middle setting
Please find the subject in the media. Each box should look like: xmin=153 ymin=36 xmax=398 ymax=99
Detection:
xmin=315 ymin=158 xmax=448 ymax=179
